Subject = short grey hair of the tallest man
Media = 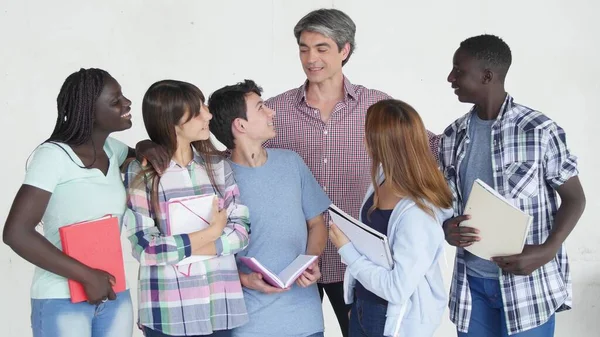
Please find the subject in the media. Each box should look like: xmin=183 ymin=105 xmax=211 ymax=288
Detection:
xmin=294 ymin=8 xmax=356 ymax=66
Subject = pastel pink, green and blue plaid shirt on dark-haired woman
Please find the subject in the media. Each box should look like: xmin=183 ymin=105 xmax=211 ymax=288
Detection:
xmin=124 ymin=154 xmax=250 ymax=336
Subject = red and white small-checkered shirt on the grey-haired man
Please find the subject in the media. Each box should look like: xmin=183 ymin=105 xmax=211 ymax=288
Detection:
xmin=265 ymin=77 xmax=438 ymax=283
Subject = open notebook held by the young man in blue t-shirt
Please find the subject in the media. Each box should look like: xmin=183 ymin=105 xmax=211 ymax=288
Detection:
xmin=240 ymin=255 xmax=317 ymax=289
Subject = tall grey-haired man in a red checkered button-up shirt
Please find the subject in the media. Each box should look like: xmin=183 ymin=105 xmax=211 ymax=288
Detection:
xmin=265 ymin=9 xmax=437 ymax=336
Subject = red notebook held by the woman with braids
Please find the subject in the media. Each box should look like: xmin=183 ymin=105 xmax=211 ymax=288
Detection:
xmin=58 ymin=216 xmax=125 ymax=303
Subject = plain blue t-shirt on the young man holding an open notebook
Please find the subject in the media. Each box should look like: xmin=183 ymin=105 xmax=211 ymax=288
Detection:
xmin=231 ymin=149 xmax=331 ymax=337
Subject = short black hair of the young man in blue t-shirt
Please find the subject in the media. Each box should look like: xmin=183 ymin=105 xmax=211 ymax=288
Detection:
xmin=208 ymin=80 xmax=262 ymax=149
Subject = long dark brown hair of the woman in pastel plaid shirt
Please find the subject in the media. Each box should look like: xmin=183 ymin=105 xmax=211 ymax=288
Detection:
xmin=128 ymin=80 xmax=222 ymax=218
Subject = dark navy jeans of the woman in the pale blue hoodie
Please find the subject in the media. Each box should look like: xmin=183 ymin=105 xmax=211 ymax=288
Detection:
xmin=348 ymin=298 xmax=387 ymax=337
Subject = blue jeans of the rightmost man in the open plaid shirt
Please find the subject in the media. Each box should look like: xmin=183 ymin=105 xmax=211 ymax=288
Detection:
xmin=458 ymin=276 xmax=554 ymax=337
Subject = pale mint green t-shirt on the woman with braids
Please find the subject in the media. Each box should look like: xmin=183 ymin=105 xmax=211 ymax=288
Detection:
xmin=23 ymin=138 xmax=128 ymax=299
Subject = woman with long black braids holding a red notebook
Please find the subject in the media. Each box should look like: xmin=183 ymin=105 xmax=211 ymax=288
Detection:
xmin=3 ymin=69 xmax=167 ymax=337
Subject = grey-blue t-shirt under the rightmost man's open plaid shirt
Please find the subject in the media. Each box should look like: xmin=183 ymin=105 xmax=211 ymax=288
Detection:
xmin=460 ymin=113 xmax=499 ymax=279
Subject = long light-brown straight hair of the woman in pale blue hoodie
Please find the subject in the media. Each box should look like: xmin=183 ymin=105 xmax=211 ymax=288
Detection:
xmin=365 ymin=99 xmax=452 ymax=216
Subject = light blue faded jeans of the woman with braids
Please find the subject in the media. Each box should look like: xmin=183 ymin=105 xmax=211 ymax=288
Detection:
xmin=31 ymin=290 xmax=133 ymax=337
